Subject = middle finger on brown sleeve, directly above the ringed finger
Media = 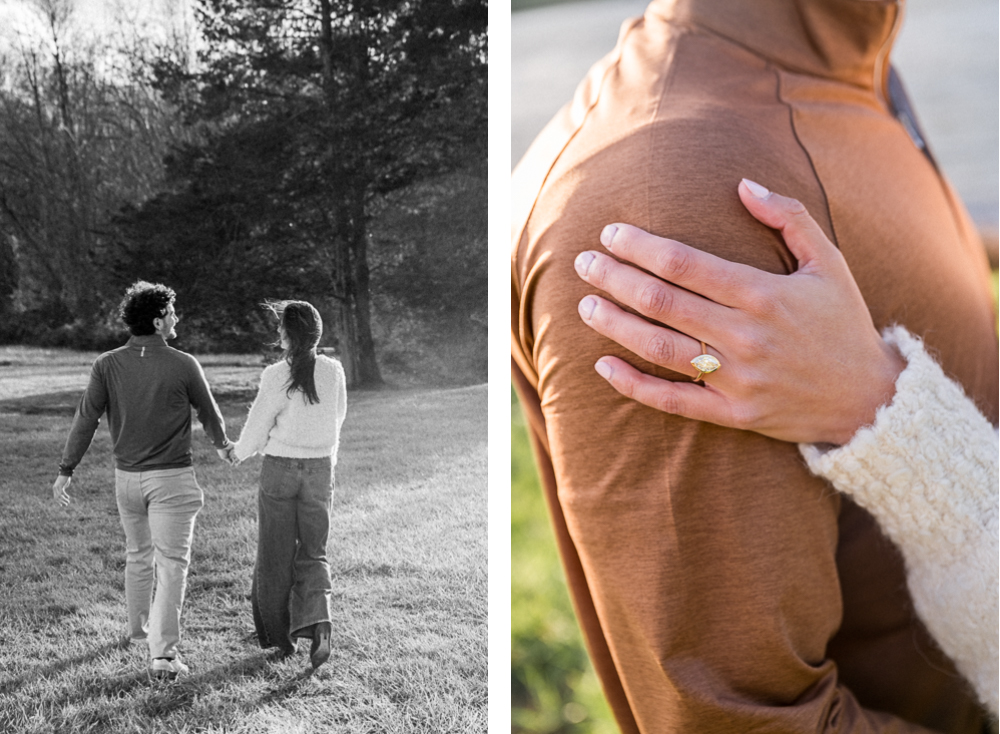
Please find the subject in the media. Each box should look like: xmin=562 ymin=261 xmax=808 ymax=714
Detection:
xmin=574 ymin=251 xmax=729 ymax=341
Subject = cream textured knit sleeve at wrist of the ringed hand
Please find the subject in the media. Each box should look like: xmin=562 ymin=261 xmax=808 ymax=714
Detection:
xmin=799 ymin=326 xmax=998 ymax=715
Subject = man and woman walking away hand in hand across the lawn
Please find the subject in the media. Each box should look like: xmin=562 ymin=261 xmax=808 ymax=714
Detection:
xmin=52 ymin=281 xmax=347 ymax=679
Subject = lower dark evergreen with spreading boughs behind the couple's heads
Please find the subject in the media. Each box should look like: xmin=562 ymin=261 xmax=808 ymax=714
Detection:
xmin=104 ymin=115 xmax=328 ymax=351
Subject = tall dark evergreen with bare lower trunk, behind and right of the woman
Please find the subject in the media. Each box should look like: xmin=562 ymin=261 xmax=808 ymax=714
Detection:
xmin=152 ymin=0 xmax=486 ymax=386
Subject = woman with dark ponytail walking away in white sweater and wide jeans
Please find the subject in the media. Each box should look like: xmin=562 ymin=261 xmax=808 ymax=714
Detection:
xmin=234 ymin=301 xmax=347 ymax=669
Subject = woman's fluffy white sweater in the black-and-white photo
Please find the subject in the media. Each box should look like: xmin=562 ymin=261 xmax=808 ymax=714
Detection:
xmin=236 ymin=355 xmax=347 ymax=465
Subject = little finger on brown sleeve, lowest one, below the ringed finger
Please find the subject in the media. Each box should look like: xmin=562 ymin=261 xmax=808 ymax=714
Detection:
xmin=594 ymin=356 xmax=732 ymax=427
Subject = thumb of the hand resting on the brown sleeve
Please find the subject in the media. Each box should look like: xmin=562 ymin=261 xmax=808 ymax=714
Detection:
xmin=739 ymin=179 xmax=842 ymax=270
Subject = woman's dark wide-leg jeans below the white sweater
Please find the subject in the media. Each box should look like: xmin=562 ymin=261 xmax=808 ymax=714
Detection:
xmin=251 ymin=456 xmax=333 ymax=652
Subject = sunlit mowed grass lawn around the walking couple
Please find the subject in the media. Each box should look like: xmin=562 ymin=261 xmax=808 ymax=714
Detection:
xmin=0 ymin=349 xmax=487 ymax=734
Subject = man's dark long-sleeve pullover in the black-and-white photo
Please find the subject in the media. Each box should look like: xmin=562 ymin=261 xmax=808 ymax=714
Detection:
xmin=59 ymin=334 xmax=227 ymax=475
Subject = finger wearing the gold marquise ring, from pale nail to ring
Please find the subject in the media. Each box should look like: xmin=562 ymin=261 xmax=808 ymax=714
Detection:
xmin=579 ymin=296 xmax=701 ymax=379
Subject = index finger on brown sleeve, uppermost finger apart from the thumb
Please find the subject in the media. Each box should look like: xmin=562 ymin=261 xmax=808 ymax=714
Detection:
xmin=601 ymin=224 xmax=762 ymax=306
